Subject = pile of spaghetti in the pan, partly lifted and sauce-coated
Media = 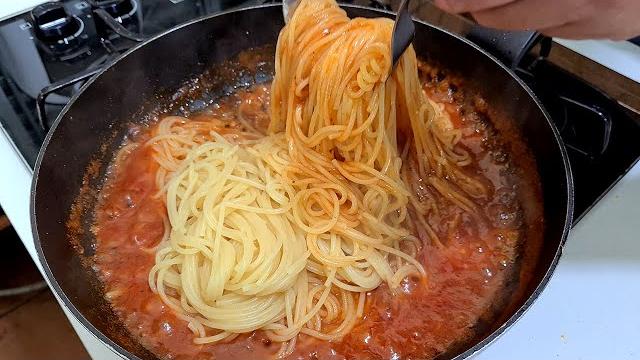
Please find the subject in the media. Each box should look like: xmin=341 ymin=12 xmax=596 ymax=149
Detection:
xmin=148 ymin=0 xmax=486 ymax=356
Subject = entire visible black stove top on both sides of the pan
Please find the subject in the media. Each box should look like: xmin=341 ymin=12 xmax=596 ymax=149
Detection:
xmin=0 ymin=0 xmax=640 ymax=219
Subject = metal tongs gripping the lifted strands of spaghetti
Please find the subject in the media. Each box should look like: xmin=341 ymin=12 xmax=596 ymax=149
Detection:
xmin=282 ymin=0 xmax=416 ymax=72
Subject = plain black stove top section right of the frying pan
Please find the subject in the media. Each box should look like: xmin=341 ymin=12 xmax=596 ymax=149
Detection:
xmin=516 ymin=52 xmax=640 ymax=224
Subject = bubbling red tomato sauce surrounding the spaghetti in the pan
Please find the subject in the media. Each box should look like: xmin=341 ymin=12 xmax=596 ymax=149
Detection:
xmin=95 ymin=66 xmax=542 ymax=359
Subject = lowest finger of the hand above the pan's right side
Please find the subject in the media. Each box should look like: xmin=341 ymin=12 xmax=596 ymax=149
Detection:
xmin=472 ymin=0 xmax=595 ymax=30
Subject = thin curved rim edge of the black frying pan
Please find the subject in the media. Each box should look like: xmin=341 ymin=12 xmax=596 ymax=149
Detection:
xmin=29 ymin=4 xmax=574 ymax=360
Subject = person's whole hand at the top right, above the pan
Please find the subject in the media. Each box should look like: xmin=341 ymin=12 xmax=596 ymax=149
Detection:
xmin=435 ymin=0 xmax=640 ymax=40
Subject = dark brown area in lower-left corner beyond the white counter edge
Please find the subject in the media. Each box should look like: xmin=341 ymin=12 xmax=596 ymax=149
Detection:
xmin=0 ymin=209 xmax=89 ymax=360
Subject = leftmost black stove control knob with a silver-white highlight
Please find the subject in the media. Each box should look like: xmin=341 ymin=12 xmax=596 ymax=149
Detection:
xmin=31 ymin=2 xmax=84 ymax=47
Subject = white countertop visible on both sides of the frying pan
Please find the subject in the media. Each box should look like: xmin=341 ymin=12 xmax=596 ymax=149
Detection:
xmin=0 ymin=119 xmax=640 ymax=360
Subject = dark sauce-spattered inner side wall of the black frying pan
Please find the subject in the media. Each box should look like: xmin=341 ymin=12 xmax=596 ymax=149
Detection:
xmin=31 ymin=5 xmax=573 ymax=359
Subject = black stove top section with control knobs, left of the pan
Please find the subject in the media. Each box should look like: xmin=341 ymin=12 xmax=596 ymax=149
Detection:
xmin=0 ymin=0 xmax=267 ymax=168
